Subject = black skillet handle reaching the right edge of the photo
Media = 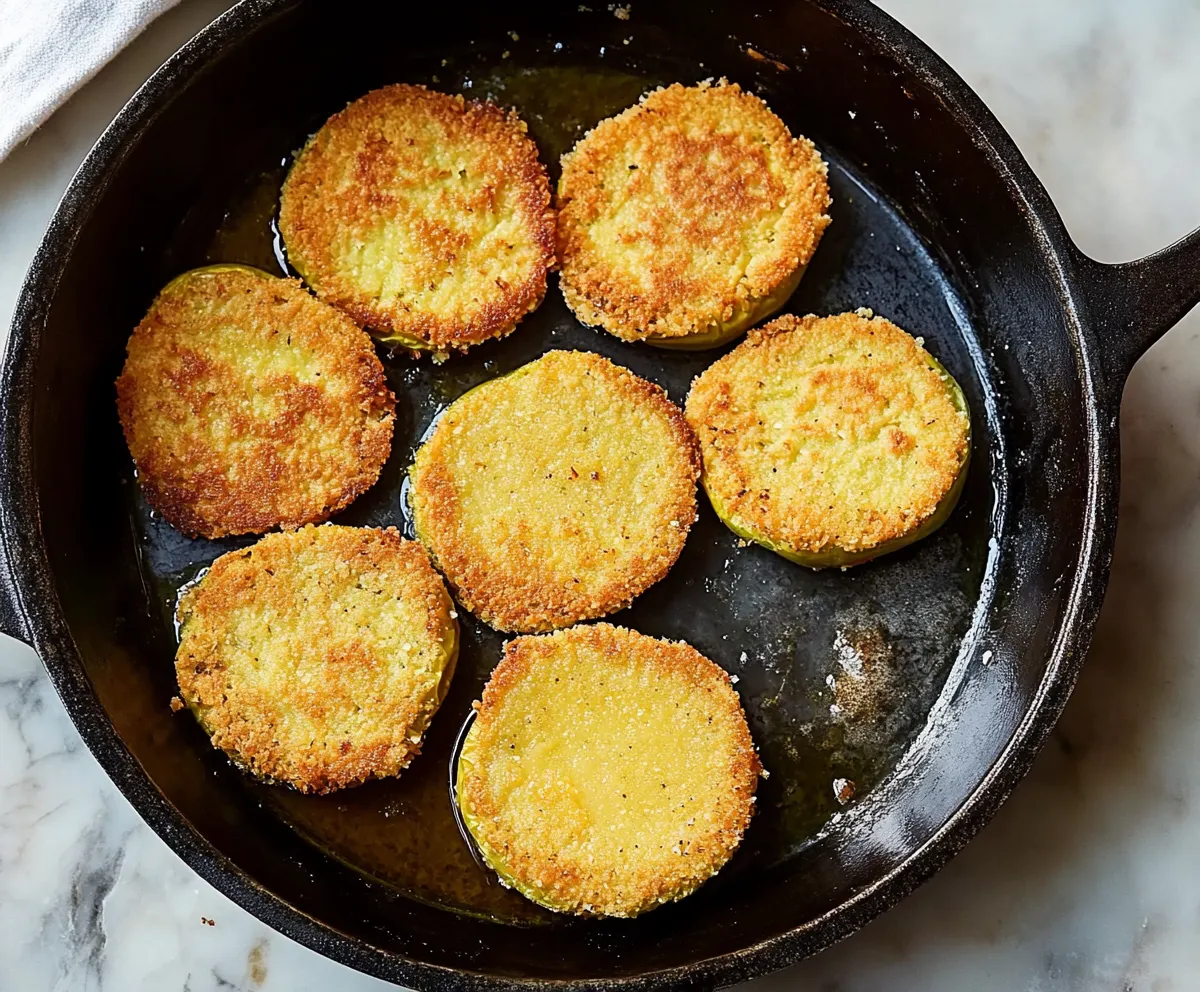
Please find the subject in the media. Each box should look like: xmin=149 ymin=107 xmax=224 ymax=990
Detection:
xmin=1079 ymin=228 xmax=1200 ymax=399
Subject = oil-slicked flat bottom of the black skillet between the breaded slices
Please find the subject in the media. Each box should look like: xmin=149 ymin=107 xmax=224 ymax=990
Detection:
xmin=128 ymin=60 xmax=992 ymax=925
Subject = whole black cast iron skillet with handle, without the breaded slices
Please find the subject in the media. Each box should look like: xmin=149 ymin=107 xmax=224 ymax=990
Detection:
xmin=0 ymin=0 xmax=1200 ymax=988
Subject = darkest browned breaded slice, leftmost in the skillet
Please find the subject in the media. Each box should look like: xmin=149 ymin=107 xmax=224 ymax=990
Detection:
xmin=116 ymin=265 xmax=396 ymax=537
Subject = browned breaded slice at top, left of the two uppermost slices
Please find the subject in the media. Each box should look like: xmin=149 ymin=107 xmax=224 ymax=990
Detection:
xmin=280 ymin=84 xmax=554 ymax=351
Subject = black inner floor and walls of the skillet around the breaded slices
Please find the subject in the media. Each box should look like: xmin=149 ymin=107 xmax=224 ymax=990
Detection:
xmin=18 ymin=4 xmax=1099 ymax=978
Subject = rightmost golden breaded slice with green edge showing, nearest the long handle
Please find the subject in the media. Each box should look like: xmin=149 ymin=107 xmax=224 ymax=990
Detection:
xmin=686 ymin=309 xmax=971 ymax=567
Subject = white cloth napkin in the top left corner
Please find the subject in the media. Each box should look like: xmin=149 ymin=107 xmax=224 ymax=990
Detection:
xmin=0 ymin=0 xmax=179 ymax=160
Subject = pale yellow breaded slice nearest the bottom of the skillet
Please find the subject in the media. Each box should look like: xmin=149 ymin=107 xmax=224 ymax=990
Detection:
xmin=456 ymin=624 xmax=762 ymax=916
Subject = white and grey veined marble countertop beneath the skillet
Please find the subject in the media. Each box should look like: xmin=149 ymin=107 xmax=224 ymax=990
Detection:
xmin=0 ymin=0 xmax=1200 ymax=992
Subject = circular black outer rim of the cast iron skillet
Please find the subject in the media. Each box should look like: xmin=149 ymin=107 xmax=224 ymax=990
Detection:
xmin=0 ymin=0 xmax=1120 ymax=992
